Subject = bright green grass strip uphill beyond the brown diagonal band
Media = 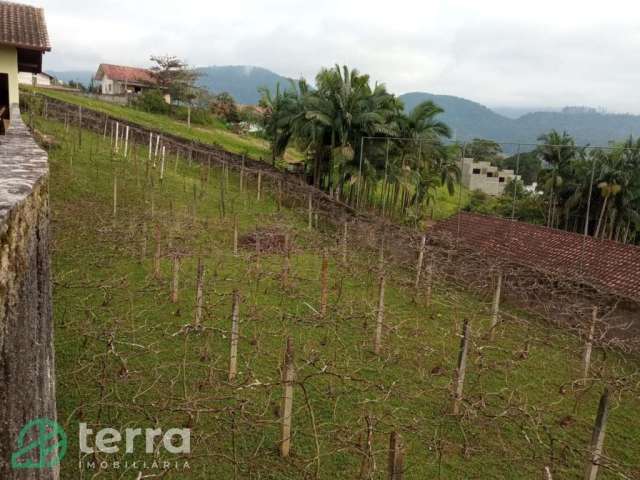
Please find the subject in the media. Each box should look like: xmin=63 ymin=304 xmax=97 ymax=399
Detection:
xmin=21 ymin=87 xmax=301 ymax=162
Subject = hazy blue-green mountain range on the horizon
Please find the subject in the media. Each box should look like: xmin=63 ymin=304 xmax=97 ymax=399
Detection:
xmin=49 ymin=65 xmax=640 ymax=147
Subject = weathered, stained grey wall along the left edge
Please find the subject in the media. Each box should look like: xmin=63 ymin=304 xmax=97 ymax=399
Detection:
xmin=0 ymin=105 xmax=59 ymax=479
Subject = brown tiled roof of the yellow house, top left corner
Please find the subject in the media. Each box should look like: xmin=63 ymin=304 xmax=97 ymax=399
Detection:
xmin=0 ymin=1 xmax=51 ymax=52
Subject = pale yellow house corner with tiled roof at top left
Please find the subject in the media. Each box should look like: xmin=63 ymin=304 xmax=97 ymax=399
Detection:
xmin=0 ymin=1 xmax=51 ymax=128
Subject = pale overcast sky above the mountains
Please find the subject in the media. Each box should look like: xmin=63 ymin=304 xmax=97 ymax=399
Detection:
xmin=37 ymin=0 xmax=640 ymax=113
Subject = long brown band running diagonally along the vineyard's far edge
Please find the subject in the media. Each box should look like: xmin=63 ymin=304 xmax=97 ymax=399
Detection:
xmin=21 ymin=92 xmax=637 ymax=478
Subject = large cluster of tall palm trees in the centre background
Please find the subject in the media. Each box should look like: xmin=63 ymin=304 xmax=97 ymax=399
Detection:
xmin=261 ymin=65 xmax=460 ymax=227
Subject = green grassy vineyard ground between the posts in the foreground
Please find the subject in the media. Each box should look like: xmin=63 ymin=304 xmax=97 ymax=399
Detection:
xmin=38 ymin=113 xmax=640 ymax=480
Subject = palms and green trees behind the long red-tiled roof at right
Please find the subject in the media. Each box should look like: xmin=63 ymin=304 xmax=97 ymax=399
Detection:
xmin=467 ymin=130 xmax=640 ymax=243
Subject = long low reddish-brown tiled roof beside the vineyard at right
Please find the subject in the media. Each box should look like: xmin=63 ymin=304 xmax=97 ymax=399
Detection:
xmin=431 ymin=212 xmax=640 ymax=299
